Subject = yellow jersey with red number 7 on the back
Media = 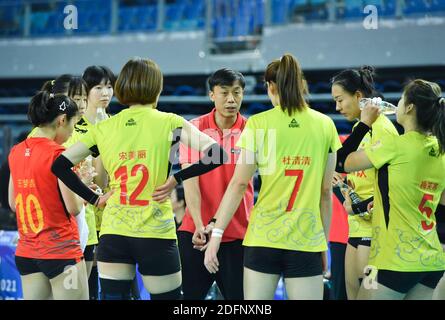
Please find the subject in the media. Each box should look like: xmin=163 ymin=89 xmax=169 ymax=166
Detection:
xmin=237 ymin=107 xmax=341 ymax=252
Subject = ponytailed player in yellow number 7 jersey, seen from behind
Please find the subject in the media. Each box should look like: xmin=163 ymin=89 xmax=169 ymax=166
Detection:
xmin=204 ymin=54 xmax=341 ymax=300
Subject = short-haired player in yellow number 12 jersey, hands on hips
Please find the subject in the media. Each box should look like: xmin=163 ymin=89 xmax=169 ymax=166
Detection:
xmin=52 ymin=58 xmax=227 ymax=300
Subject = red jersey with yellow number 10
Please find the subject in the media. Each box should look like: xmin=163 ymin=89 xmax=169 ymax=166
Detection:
xmin=8 ymin=138 xmax=83 ymax=259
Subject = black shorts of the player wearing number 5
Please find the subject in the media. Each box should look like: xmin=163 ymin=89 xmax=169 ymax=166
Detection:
xmin=377 ymin=270 xmax=445 ymax=294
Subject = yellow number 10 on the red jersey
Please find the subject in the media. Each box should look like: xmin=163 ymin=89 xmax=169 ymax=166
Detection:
xmin=15 ymin=193 xmax=44 ymax=233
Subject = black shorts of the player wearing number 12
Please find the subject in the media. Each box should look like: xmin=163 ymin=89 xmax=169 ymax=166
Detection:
xmin=97 ymin=234 xmax=181 ymax=276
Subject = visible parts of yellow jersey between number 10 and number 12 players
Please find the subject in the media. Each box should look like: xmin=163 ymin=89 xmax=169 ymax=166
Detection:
xmin=63 ymin=116 xmax=99 ymax=246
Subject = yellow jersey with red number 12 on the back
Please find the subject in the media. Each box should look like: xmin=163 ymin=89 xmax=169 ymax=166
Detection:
xmin=81 ymin=107 xmax=184 ymax=239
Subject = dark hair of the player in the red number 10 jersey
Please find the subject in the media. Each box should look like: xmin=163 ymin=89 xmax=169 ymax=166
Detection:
xmin=28 ymin=91 xmax=79 ymax=127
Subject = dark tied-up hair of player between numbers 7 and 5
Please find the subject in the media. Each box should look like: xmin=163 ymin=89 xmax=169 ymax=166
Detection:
xmin=331 ymin=66 xmax=378 ymax=98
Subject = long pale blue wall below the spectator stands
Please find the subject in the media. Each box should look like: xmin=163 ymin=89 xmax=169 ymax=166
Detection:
xmin=0 ymin=18 xmax=445 ymax=78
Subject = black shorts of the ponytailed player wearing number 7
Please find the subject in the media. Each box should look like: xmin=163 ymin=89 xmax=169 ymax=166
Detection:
xmin=244 ymin=247 xmax=323 ymax=278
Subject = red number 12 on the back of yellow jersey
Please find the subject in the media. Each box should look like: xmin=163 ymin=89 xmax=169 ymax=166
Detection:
xmin=114 ymin=164 xmax=149 ymax=206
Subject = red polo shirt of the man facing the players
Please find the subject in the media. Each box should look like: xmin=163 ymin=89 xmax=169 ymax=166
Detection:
xmin=179 ymin=109 xmax=253 ymax=242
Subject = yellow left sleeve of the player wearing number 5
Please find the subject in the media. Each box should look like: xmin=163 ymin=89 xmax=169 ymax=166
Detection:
xmin=364 ymin=135 xmax=398 ymax=169
